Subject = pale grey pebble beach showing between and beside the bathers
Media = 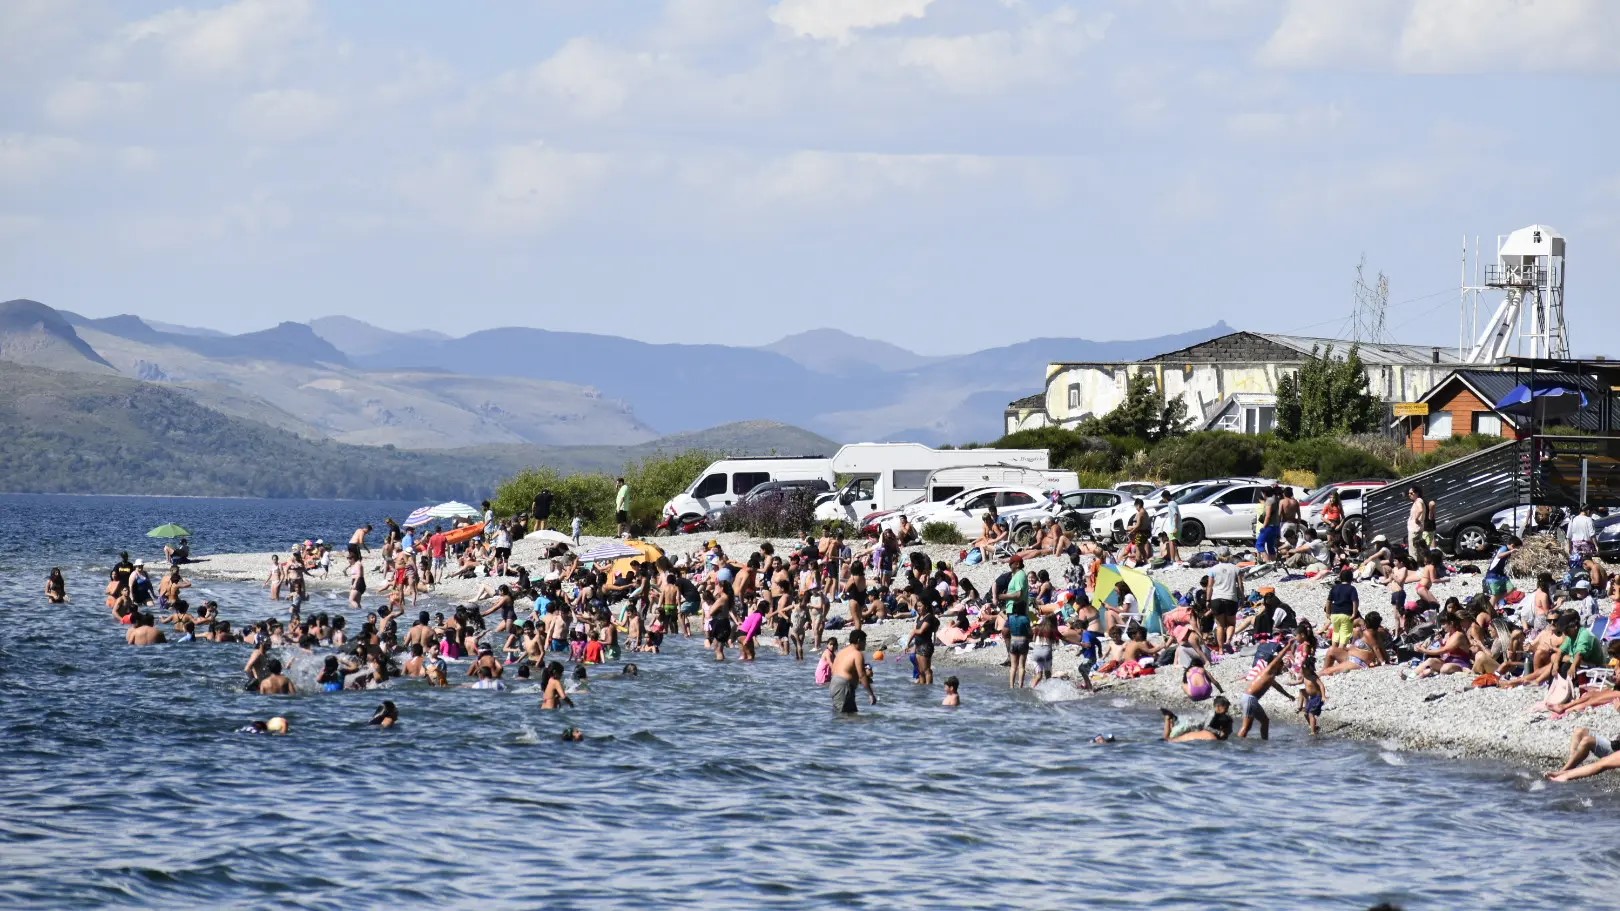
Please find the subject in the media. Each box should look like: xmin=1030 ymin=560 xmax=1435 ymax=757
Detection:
xmin=181 ymin=533 xmax=1620 ymax=772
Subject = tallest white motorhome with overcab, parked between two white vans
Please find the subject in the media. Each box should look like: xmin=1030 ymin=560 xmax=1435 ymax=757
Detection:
xmin=815 ymin=443 xmax=1050 ymax=524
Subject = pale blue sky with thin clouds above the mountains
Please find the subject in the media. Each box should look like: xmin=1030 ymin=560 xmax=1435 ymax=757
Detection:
xmin=0 ymin=0 xmax=1620 ymax=355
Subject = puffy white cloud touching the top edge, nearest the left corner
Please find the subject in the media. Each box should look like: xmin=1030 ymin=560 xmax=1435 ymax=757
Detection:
xmin=123 ymin=0 xmax=314 ymax=76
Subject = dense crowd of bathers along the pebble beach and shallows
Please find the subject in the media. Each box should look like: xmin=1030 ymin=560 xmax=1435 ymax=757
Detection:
xmin=69 ymin=488 xmax=1620 ymax=778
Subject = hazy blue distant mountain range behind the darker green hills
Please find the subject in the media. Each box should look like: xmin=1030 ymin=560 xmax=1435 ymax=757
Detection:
xmin=0 ymin=300 xmax=1230 ymax=490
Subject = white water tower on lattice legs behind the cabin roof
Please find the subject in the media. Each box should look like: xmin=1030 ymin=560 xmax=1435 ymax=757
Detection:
xmin=1464 ymin=225 xmax=1570 ymax=363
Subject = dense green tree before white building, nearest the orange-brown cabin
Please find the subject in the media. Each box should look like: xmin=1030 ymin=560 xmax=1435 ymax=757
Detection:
xmin=1277 ymin=344 xmax=1382 ymax=439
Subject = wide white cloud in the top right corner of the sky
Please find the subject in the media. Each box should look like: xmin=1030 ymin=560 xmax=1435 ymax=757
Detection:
xmin=1257 ymin=0 xmax=1620 ymax=73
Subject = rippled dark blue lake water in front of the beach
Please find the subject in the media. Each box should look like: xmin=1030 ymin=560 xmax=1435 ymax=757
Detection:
xmin=0 ymin=496 xmax=1620 ymax=909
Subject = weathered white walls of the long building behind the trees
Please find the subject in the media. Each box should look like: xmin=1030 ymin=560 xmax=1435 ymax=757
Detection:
xmin=1004 ymin=332 xmax=1458 ymax=433
